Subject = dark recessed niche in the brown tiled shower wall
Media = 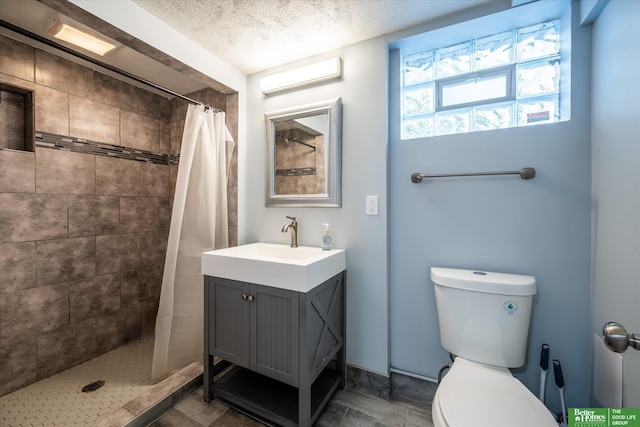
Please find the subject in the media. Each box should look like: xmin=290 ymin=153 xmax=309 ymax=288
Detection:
xmin=0 ymin=83 xmax=35 ymax=151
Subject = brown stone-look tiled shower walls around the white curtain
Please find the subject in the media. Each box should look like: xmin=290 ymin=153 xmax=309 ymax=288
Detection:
xmin=0 ymin=36 xmax=237 ymax=395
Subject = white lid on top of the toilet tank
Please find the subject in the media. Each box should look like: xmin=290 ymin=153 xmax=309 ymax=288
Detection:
xmin=431 ymin=267 xmax=537 ymax=296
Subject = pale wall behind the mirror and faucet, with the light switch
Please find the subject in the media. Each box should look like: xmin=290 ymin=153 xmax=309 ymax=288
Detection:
xmin=248 ymin=37 xmax=389 ymax=375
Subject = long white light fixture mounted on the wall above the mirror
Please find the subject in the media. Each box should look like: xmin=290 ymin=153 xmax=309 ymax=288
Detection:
xmin=260 ymin=56 xmax=342 ymax=95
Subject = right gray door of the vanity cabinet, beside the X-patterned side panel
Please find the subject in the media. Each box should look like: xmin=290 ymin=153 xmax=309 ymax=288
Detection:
xmin=250 ymin=285 xmax=299 ymax=387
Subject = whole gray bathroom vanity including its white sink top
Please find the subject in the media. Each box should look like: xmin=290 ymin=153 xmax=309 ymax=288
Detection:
xmin=202 ymin=244 xmax=346 ymax=426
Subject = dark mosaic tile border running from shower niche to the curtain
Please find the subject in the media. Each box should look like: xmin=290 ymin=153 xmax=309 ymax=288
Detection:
xmin=36 ymin=132 xmax=180 ymax=165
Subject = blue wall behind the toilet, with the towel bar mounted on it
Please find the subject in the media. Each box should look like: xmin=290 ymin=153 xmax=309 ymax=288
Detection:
xmin=389 ymin=0 xmax=591 ymax=410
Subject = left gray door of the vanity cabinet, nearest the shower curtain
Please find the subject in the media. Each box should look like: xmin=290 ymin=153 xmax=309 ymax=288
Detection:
xmin=209 ymin=278 xmax=251 ymax=368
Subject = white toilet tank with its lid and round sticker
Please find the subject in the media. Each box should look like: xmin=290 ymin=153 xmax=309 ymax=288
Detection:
xmin=431 ymin=267 xmax=536 ymax=368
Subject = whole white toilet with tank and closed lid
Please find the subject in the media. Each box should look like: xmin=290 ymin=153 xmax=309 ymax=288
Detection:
xmin=431 ymin=267 xmax=558 ymax=427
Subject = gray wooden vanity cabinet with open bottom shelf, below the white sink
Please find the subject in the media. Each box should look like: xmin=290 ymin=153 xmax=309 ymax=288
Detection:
xmin=203 ymin=272 xmax=346 ymax=426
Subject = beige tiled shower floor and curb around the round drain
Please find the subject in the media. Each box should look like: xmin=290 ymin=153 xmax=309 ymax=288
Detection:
xmin=0 ymin=338 xmax=202 ymax=427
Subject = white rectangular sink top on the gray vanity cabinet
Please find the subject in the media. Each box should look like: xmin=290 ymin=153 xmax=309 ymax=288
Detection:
xmin=202 ymin=243 xmax=347 ymax=292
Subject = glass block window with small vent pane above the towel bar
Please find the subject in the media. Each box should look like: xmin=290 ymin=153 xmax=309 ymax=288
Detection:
xmin=400 ymin=20 xmax=561 ymax=139
